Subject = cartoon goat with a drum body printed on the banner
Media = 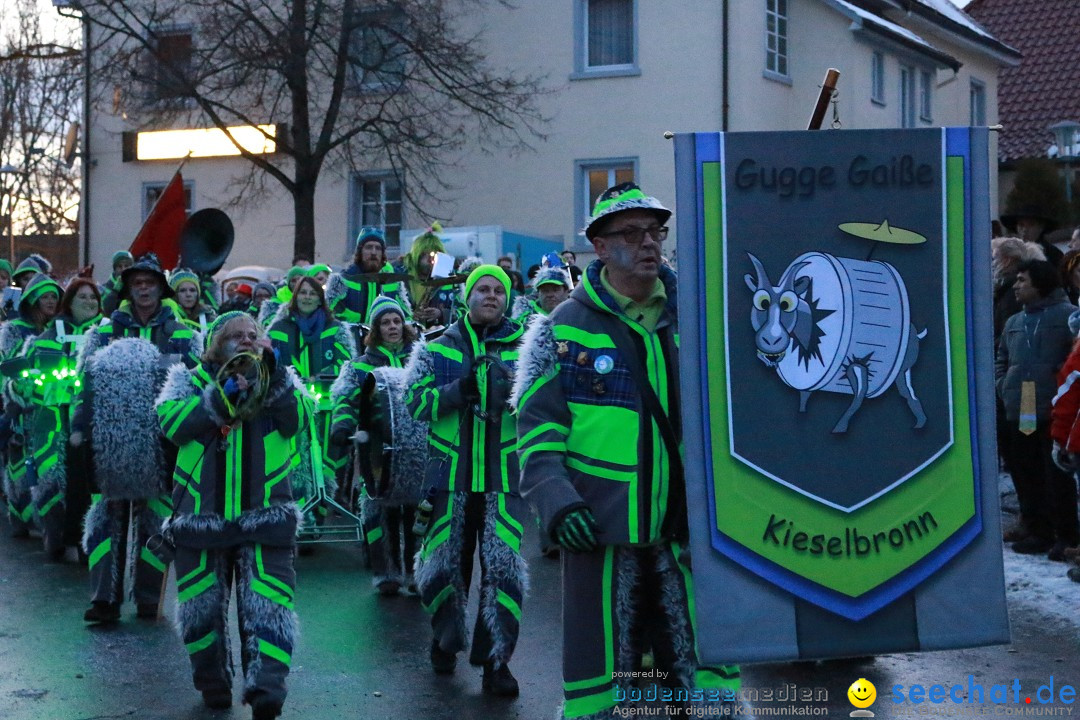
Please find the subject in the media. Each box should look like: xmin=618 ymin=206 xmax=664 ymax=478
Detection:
xmin=744 ymin=253 xmax=927 ymax=433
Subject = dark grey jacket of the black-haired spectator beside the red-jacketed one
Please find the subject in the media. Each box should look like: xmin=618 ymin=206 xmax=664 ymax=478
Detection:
xmin=995 ymin=288 xmax=1076 ymax=423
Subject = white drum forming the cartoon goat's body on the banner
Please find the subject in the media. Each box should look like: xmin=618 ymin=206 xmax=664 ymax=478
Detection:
xmin=777 ymin=253 xmax=912 ymax=397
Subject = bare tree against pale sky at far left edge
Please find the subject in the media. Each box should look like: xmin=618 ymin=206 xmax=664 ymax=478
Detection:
xmin=0 ymin=0 xmax=82 ymax=241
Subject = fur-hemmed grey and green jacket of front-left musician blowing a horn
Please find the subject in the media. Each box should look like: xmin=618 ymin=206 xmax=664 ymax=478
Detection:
xmin=156 ymin=362 xmax=310 ymax=548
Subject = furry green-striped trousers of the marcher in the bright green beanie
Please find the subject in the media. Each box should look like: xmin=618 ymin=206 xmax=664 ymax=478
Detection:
xmin=416 ymin=492 xmax=528 ymax=665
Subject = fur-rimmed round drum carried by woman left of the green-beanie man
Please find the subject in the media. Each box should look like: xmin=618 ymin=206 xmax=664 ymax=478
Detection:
xmin=356 ymin=367 xmax=428 ymax=505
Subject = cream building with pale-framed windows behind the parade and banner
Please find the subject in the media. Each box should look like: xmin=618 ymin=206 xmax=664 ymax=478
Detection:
xmin=71 ymin=0 xmax=1020 ymax=274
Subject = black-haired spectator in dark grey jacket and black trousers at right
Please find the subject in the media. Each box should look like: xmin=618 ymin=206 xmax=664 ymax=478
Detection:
xmin=995 ymin=260 xmax=1080 ymax=560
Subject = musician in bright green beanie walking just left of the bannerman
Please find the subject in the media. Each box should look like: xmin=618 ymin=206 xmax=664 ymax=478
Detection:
xmin=405 ymin=255 xmax=526 ymax=697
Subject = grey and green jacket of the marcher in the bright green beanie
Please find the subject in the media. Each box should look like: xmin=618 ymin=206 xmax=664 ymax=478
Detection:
xmin=405 ymin=316 xmax=524 ymax=494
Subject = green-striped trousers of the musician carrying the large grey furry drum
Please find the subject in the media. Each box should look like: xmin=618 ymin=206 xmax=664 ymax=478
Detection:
xmin=83 ymin=495 xmax=172 ymax=604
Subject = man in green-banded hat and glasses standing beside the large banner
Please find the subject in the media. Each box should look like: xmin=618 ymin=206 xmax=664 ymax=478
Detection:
xmin=512 ymin=184 xmax=739 ymax=718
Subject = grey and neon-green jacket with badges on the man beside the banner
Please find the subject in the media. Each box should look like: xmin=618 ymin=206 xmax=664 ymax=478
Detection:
xmin=512 ymin=260 xmax=685 ymax=545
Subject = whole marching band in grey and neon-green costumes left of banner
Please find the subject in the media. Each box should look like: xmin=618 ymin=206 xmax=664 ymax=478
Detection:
xmin=0 ymin=184 xmax=743 ymax=720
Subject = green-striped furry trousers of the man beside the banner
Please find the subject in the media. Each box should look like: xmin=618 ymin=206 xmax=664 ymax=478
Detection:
xmin=562 ymin=542 xmax=739 ymax=718
